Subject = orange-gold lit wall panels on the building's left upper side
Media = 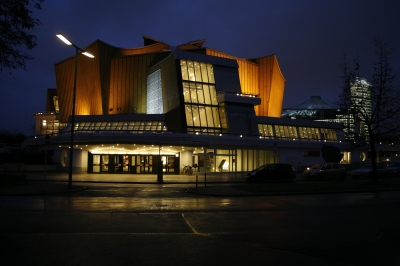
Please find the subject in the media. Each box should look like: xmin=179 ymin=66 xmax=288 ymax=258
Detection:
xmin=55 ymin=40 xmax=168 ymax=122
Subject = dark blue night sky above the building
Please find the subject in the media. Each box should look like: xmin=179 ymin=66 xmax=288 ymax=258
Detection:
xmin=0 ymin=0 xmax=400 ymax=135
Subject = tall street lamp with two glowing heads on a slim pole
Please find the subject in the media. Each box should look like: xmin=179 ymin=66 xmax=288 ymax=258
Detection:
xmin=56 ymin=34 xmax=94 ymax=189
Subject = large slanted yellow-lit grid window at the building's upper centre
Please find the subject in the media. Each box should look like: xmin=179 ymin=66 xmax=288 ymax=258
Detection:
xmin=180 ymin=60 xmax=221 ymax=135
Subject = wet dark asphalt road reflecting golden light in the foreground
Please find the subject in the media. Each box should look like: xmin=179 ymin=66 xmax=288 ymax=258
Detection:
xmin=0 ymin=184 xmax=400 ymax=265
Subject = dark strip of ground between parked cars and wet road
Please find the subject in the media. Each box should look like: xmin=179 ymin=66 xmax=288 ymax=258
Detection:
xmin=235 ymin=179 xmax=400 ymax=193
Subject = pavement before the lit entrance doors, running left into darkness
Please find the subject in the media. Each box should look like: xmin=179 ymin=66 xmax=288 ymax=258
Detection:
xmin=0 ymin=172 xmax=251 ymax=196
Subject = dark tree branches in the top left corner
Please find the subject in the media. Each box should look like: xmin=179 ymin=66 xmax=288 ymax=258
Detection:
xmin=0 ymin=0 xmax=44 ymax=74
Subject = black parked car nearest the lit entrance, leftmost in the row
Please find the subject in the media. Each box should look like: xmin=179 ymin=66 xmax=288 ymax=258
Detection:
xmin=245 ymin=163 xmax=296 ymax=182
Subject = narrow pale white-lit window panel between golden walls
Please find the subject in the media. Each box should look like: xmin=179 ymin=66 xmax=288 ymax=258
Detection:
xmin=146 ymin=69 xmax=163 ymax=114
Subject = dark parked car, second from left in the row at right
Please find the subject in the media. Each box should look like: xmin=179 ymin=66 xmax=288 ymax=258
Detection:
xmin=303 ymin=163 xmax=347 ymax=180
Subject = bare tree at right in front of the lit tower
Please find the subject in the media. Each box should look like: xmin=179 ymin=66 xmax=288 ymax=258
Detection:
xmin=339 ymin=37 xmax=400 ymax=182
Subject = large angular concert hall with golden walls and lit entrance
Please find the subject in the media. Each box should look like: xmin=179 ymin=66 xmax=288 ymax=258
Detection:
xmin=26 ymin=36 xmax=346 ymax=175
